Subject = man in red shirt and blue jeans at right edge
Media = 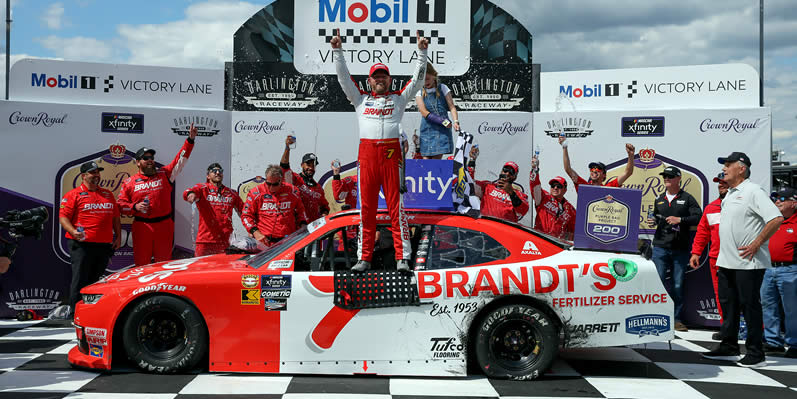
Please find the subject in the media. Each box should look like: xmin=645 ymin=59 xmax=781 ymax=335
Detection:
xmin=761 ymin=187 xmax=797 ymax=358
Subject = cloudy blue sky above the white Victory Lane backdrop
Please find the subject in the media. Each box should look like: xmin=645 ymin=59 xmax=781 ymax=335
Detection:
xmin=0 ymin=0 xmax=797 ymax=163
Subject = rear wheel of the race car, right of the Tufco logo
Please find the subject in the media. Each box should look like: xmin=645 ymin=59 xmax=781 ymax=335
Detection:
xmin=476 ymin=304 xmax=559 ymax=380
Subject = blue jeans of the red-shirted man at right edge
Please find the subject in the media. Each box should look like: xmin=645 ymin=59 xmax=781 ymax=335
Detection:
xmin=761 ymin=265 xmax=797 ymax=347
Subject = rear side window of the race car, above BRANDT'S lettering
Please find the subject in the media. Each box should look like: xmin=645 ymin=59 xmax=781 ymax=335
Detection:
xmin=415 ymin=225 xmax=509 ymax=270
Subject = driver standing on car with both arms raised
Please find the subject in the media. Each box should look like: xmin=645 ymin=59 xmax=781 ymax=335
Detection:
xmin=330 ymin=30 xmax=429 ymax=271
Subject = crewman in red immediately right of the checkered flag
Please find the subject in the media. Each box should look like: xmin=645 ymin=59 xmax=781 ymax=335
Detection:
xmin=475 ymin=161 xmax=529 ymax=222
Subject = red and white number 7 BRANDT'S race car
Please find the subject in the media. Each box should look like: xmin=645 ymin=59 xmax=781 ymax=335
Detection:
xmin=69 ymin=210 xmax=674 ymax=379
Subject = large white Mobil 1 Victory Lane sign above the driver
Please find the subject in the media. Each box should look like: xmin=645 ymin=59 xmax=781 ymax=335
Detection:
xmin=293 ymin=0 xmax=471 ymax=75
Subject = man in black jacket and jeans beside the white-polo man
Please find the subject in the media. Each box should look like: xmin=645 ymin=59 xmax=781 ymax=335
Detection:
xmin=648 ymin=166 xmax=702 ymax=331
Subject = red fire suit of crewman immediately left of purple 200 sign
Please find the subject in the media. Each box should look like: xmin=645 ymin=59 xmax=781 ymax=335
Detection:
xmin=529 ymin=172 xmax=576 ymax=241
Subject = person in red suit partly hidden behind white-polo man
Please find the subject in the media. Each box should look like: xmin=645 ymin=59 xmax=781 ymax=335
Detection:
xmin=689 ymin=172 xmax=728 ymax=332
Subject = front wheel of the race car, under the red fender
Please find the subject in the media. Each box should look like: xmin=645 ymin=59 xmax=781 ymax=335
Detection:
xmin=123 ymin=295 xmax=208 ymax=374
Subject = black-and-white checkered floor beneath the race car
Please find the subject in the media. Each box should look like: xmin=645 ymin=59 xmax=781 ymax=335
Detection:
xmin=0 ymin=320 xmax=797 ymax=399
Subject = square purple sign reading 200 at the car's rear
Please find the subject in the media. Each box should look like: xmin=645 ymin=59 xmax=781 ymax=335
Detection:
xmin=574 ymin=184 xmax=642 ymax=252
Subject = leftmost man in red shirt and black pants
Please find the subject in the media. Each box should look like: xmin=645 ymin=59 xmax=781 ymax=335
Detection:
xmin=58 ymin=161 xmax=122 ymax=314
